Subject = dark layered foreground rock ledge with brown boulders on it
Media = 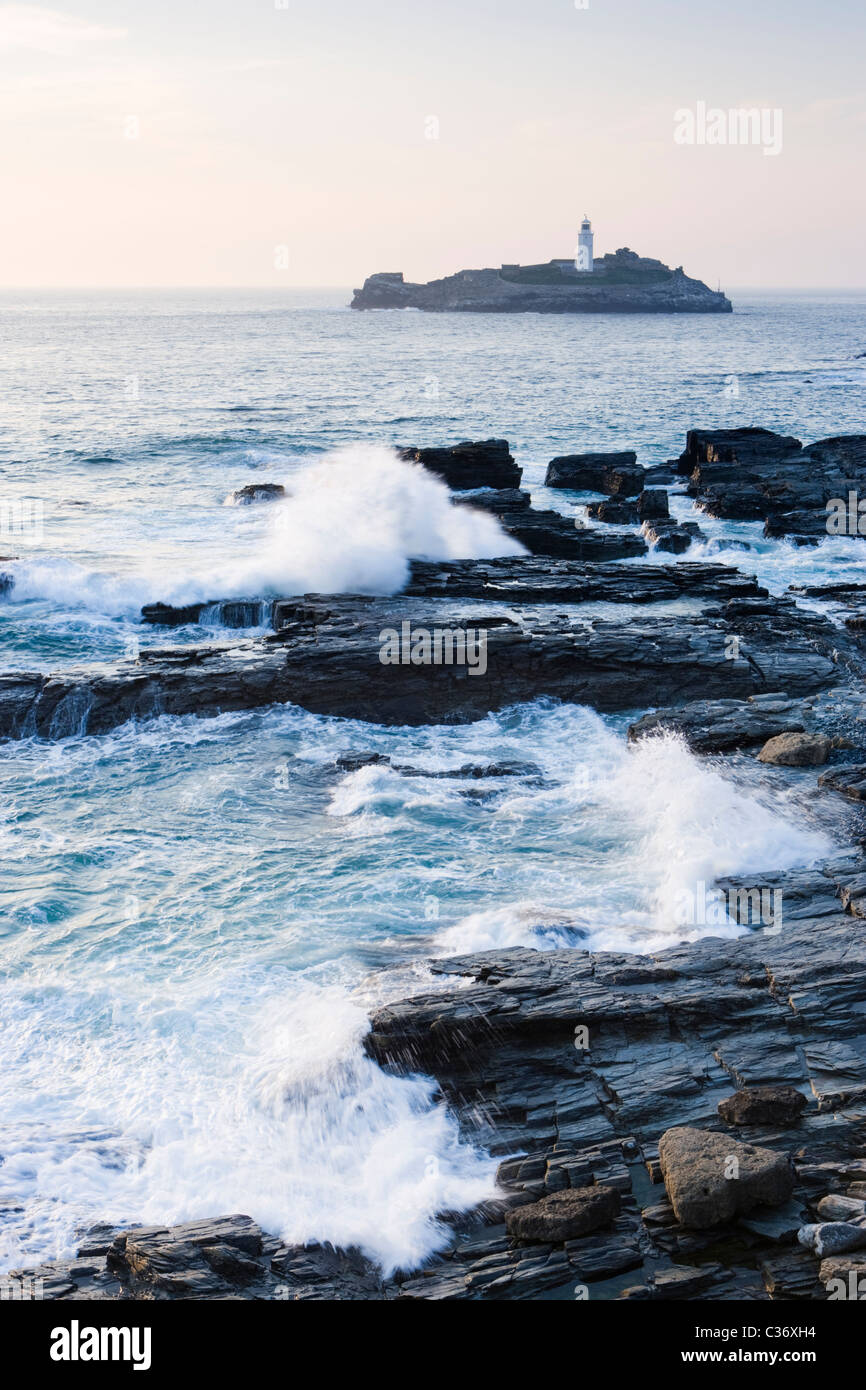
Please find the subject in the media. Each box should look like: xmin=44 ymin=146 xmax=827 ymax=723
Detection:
xmin=11 ymin=878 xmax=866 ymax=1300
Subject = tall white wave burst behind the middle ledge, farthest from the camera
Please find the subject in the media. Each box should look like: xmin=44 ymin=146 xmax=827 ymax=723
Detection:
xmin=6 ymin=445 xmax=524 ymax=617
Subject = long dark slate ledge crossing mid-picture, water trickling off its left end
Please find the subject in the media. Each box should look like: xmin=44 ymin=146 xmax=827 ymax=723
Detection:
xmin=0 ymin=596 xmax=837 ymax=738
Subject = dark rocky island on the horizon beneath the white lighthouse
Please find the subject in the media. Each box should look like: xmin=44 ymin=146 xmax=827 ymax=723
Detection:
xmin=350 ymin=247 xmax=733 ymax=314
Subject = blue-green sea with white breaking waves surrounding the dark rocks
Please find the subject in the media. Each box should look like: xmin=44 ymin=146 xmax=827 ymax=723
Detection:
xmin=0 ymin=289 xmax=866 ymax=1270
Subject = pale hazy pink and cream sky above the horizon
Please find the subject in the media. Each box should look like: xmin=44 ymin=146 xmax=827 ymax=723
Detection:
xmin=0 ymin=0 xmax=866 ymax=288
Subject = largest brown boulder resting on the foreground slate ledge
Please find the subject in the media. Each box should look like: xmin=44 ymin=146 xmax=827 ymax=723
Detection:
xmin=659 ymin=1126 xmax=794 ymax=1230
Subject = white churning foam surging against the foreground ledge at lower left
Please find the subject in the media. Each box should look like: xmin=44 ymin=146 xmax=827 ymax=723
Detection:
xmin=0 ymin=980 xmax=495 ymax=1270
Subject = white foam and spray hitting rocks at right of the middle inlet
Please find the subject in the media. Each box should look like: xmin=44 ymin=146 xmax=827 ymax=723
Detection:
xmin=436 ymin=710 xmax=833 ymax=955
